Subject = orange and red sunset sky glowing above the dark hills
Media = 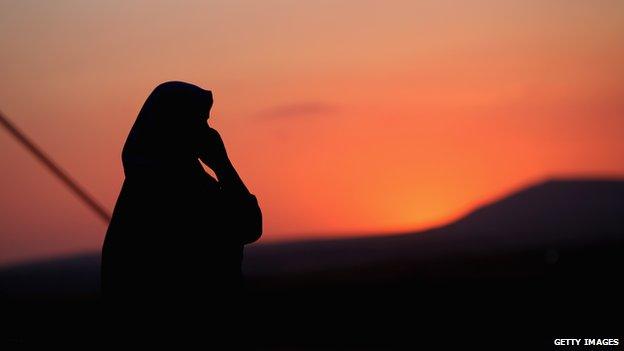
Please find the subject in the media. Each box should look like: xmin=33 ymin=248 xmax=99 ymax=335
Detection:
xmin=0 ymin=0 xmax=624 ymax=264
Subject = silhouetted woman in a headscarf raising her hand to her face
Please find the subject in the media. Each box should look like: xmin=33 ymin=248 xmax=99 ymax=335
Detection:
xmin=102 ymin=82 xmax=262 ymax=299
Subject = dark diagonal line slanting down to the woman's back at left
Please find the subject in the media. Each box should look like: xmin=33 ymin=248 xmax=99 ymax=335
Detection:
xmin=0 ymin=111 xmax=111 ymax=223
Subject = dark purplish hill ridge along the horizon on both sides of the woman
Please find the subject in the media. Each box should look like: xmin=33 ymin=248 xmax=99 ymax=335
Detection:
xmin=0 ymin=180 xmax=624 ymax=295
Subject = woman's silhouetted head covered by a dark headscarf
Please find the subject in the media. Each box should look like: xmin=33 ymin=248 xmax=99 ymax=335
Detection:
xmin=122 ymin=82 xmax=213 ymax=174
